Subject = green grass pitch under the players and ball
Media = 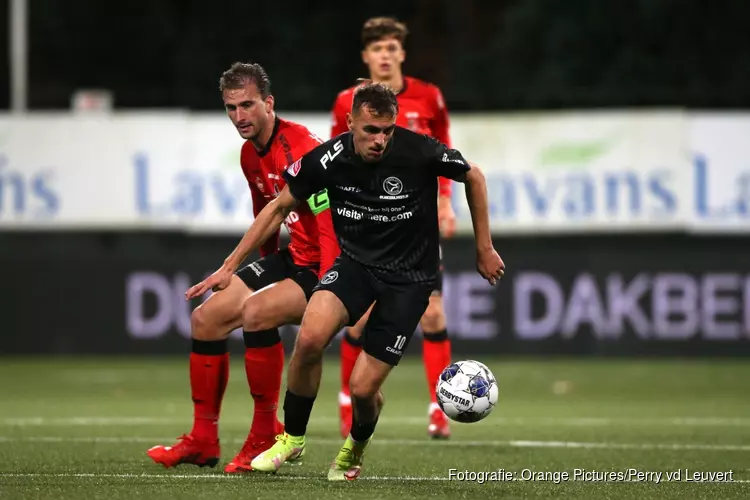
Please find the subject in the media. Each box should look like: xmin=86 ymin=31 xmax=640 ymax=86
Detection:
xmin=0 ymin=357 xmax=750 ymax=500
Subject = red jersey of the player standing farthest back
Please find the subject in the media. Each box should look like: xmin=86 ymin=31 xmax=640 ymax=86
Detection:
xmin=331 ymin=76 xmax=451 ymax=196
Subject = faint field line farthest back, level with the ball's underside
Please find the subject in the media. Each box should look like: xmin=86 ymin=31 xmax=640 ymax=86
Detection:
xmin=0 ymin=416 xmax=750 ymax=427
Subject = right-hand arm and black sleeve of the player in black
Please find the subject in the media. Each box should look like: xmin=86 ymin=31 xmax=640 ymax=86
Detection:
xmin=430 ymin=138 xmax=505 ymax=286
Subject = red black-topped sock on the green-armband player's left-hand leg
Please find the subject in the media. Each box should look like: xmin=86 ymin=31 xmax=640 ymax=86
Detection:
xmin=190 ymin=339 xmax=229 ymax=442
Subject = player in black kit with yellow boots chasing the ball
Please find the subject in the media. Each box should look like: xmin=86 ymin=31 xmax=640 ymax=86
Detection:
xmin=228 ymin=83 xmax=505 ymax=481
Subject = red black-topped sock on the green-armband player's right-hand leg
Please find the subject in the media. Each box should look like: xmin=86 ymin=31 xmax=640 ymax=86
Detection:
xmin=244 ymin=328 xmax=284 ymax=436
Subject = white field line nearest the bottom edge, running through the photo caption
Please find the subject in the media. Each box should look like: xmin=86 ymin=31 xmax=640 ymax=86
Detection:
xmin=0 ymin=472 xmax=750 ymax=484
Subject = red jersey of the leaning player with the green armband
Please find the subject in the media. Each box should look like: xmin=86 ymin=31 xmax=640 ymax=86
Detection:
xmin=240 ymin=117 xmax=339 ymax=274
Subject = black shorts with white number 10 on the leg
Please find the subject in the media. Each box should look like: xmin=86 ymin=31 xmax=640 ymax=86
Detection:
xmin=315 ymin=256 xmax=435 ymax=366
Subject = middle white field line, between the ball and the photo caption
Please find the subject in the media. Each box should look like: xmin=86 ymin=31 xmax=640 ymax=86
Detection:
xmin=0 ymin=436 xmax=750 ymax=451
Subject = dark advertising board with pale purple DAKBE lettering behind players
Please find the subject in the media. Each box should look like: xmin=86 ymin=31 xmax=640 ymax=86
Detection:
xmin=0 ymin=232 xmax=750 ymax=356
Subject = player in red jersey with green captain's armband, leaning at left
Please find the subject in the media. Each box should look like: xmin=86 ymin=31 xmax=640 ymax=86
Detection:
xmin=148 ymin=63 xmax=339 ymax=473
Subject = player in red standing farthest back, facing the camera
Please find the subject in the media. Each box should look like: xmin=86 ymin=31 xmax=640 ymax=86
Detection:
xmin=331 ymin=17 xmax=456 ymax=438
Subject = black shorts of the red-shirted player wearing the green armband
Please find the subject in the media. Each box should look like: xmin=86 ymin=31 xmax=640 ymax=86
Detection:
xmin=236 ymin=248 xmax=318 ymax=300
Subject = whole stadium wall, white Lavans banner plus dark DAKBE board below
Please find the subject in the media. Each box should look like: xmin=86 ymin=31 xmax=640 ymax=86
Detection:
xmin=0 ymin=110 xmax=750 ymax=355
